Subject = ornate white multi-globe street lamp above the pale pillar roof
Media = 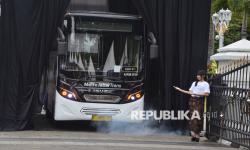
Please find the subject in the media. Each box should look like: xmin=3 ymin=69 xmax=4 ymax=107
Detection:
xmin=212 ymin=9 xmax=232 ymax=48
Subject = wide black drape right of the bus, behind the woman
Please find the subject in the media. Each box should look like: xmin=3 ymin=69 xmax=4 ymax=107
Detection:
xmin=114 ymin=0 xmax=211 ymax=129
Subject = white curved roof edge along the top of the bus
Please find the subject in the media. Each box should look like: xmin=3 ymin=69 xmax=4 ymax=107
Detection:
xmin=66 ymin=11 xmax=142 ymax=20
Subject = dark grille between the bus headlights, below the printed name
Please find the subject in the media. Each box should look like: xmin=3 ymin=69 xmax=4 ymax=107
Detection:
xmin=84 ymin=94 xmax=121 ymax=103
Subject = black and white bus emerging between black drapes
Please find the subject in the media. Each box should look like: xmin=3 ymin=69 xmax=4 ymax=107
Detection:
xmin=45 ymin=12 xmax=147 ymax=122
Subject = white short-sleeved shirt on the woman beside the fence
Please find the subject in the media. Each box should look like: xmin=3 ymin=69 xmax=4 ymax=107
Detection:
xmin=189 ymin=81 xmax=210 ymax=94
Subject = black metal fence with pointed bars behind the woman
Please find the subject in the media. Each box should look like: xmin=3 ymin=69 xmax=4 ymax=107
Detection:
xmin=207 ymin=58 xmax=250 ymax=149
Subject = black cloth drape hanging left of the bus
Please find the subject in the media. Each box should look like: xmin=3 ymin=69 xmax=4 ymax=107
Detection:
xmin=0 ymin=0 xmax=69 ymax=130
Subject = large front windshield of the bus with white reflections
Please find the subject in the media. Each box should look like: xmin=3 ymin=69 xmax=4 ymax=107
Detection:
xmin=59 ymin=17 xmax=143 ymax=81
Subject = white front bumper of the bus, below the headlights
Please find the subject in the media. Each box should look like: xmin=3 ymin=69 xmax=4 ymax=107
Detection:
xmin=54 ymin=92 xmax=144 ymax=122
